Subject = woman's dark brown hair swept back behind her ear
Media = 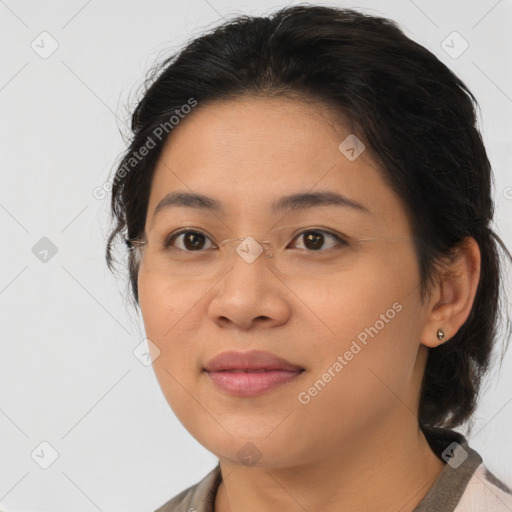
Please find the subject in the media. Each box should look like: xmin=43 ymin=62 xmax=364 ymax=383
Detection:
xmin=106 ymin=5 xmax=511 ymax=427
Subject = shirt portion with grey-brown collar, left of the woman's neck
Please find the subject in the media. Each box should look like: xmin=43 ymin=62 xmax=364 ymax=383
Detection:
xmin=155 ymin=464 xmax=222 ymax=512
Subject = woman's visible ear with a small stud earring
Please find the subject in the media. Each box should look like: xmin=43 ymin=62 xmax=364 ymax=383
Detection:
xmin=421 ymin=237 xmax=481 ymax=348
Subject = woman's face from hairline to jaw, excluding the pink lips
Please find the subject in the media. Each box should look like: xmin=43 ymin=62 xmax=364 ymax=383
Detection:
xmin=138 ymin=97 xmax=426 ymax=467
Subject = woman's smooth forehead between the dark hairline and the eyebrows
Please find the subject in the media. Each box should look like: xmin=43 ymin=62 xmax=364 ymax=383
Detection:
xmin=147 ymin=97 xmax=412 ymax=233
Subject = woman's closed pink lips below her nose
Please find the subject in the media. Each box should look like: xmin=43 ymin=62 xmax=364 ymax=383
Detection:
xmin=205 ymin=350 xmax=304 ymax=396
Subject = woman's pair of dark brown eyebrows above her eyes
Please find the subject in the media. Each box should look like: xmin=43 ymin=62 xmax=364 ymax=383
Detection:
xmin=153 ymin=191 xmax=371 ymax=215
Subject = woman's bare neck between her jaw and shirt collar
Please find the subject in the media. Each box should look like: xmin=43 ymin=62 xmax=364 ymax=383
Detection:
xmin=215 ymin=410 xmax=444 ymax=512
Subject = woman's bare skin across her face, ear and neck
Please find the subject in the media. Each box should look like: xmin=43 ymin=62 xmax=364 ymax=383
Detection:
xmin=138 ymin=97 xmax=480 ymax=512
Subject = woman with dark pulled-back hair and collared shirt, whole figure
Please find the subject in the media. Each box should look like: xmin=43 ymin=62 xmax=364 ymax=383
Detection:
xmin=107 ymin=6 xmax=512 ymax=512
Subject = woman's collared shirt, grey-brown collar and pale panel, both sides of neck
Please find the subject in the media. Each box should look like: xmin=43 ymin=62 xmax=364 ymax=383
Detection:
xmin=155 ymin=427 xmax=512 ymax=512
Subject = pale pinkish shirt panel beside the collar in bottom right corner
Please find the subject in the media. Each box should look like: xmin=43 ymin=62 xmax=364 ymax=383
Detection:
xmin=454 ymin=464 xmax=512 ymax=512
